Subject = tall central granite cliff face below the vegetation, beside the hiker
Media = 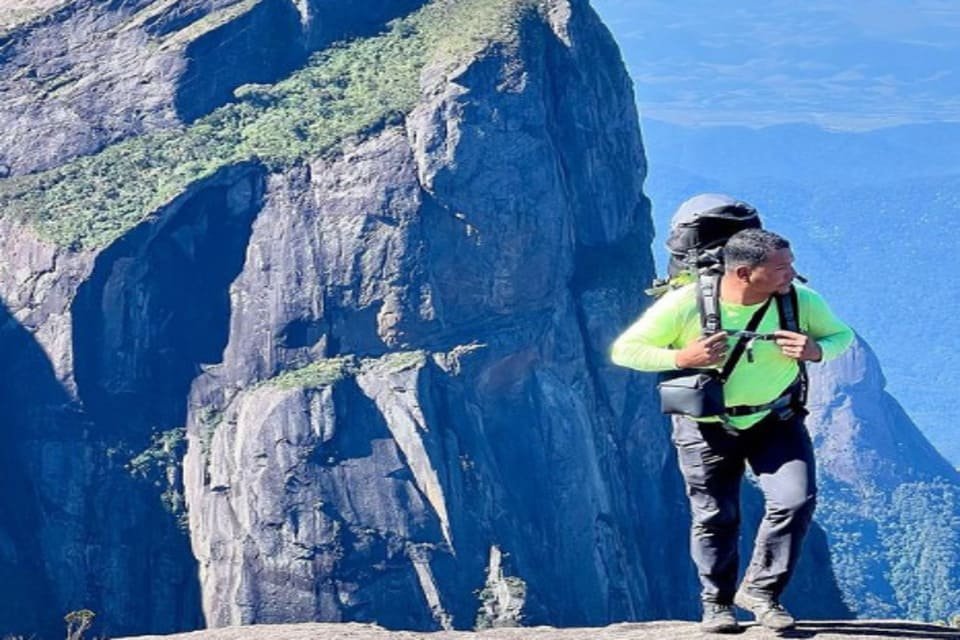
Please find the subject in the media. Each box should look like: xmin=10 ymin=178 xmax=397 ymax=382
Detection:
xmin=184 ymin=2 xmax=690 ymax=629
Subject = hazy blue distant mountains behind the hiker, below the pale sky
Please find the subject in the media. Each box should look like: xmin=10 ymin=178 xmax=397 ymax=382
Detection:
xmin=643 ymin=119 xmax=960 ymax=465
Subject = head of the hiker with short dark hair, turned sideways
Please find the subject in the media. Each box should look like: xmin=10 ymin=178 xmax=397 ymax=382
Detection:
xmin=723 ymin=229 xmax=797 ymax=295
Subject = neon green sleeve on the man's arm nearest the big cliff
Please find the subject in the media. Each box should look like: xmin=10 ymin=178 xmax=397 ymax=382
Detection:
xmin=610 ymin=289 xmax=689 ymax=371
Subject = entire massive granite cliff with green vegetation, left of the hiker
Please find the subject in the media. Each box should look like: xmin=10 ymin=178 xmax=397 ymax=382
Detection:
xmin=0 ymin=0 xmax=692 ymax=635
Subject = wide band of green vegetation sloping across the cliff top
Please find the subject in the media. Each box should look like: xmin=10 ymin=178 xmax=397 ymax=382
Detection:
xmin=0 ymin=0 xmax=536 ymax=249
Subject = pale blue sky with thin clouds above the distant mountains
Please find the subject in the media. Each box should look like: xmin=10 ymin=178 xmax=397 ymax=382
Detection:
xmin=592 ymin=0 xmax=960 ymax=130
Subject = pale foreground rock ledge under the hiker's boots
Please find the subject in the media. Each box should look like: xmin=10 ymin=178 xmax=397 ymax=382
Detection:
xmin=127 ymin=620 xmax=960 ymax=640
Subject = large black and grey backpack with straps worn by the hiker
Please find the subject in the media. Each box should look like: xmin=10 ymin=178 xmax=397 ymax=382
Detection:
xmin=647 ymin=193 xmax=808 ymax=418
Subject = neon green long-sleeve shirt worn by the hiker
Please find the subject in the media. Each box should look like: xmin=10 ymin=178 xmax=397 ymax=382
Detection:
xmin=610 ymin=284 xmax=853 ymax=429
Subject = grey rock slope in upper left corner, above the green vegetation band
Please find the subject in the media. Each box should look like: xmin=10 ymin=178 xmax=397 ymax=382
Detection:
xmin=0 ymin=0 xmax=424 ymax=177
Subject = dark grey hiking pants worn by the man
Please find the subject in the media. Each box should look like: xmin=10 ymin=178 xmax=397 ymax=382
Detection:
xmin=673 ymin=412 xmax=817 ymax=604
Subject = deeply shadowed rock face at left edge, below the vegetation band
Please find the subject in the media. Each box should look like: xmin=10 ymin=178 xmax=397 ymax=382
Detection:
xmin=0 ymin=167 xmax=276 ymax=633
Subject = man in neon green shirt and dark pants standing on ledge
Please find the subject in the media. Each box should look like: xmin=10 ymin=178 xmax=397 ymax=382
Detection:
xmin=611 ymin=222 xmax=853 ymax=633
